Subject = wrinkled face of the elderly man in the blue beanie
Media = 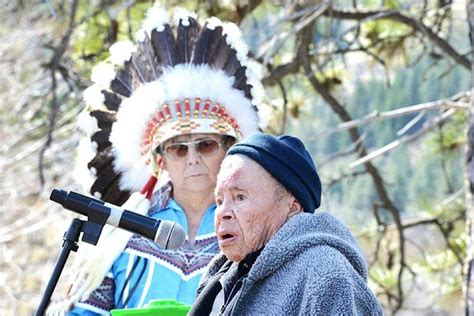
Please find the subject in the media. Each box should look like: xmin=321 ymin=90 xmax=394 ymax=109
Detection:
xmin=214 ymin=155 xmax=301 ymax=262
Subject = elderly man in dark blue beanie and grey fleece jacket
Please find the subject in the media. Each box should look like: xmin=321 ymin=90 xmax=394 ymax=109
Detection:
xmin=190 ymin=134 xmax=383 ymax=315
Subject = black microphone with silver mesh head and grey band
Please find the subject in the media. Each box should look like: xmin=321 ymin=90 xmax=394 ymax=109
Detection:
xmin=49 ymin=189 xmax=186 ymax=250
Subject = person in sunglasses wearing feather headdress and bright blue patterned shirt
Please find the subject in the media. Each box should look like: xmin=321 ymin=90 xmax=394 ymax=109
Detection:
xmin=51 ymin=5 xmax=261 ymax=315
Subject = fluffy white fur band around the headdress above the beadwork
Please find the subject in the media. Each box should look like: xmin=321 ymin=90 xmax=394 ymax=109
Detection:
xmin=110 ymin=64 xmax=258 ymax=191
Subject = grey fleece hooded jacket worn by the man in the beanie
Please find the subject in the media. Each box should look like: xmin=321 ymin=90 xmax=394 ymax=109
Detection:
xmin=192 ymin=213 xmax=383 ymax=315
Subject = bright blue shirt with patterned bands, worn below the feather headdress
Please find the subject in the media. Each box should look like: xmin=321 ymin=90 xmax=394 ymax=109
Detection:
xmin=68 ymin=199 xmax=219 ymax=315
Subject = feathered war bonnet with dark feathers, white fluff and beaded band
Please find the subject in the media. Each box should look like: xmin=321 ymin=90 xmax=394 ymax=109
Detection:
xmin=76 ymin=5 xmax=262 ymax=204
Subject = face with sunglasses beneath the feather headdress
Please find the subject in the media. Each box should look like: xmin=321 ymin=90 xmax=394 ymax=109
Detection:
xmin=161 ymin=134 xmax=226 ymax=192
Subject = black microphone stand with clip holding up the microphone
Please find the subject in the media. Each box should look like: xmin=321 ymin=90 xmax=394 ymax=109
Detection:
xmin=34 ymin=204 xmax=109 ymax=316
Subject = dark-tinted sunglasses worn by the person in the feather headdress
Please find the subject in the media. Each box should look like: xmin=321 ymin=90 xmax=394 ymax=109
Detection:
xmin=160 ymin=139 xmax=222 ymax=160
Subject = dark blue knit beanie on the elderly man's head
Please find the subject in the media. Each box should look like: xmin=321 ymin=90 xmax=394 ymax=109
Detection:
xmin=227 ymin=133 xmax=321 ymax=213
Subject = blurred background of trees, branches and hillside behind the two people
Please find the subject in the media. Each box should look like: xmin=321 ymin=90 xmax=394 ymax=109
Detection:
xmin=0 ymin=0 xmax=471 ymax=315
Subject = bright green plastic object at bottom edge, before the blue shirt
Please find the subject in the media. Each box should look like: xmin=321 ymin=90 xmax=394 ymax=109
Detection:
xmin=110 ymin=300 xmax=191 ymax=316
